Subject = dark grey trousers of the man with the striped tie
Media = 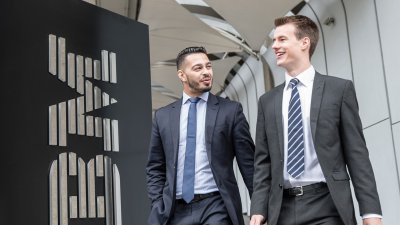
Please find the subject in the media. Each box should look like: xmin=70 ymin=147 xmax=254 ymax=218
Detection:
xmin=277 ymin=184 xmax=344 ymax=225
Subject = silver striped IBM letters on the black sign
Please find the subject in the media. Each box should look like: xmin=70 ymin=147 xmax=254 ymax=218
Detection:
xmin=49 ymin=34 xmax=122 ymax=225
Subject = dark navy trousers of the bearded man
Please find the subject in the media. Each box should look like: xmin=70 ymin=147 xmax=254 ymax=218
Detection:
xmin=168 ymin=195 xmax=232 ymax=225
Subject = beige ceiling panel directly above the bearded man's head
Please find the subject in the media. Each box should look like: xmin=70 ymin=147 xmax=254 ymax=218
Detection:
xmin=138 ymin=0 xmax=241 ymax=64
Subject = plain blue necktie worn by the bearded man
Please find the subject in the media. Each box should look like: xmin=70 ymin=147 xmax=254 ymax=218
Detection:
xmin=182 ymin=98 xmax=200 ymax=203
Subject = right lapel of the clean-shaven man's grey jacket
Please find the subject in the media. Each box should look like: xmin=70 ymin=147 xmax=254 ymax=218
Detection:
xmin=310 ymin=72 xmax=325 ymax=143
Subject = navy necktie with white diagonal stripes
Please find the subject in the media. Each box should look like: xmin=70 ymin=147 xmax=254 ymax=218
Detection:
xmin=287 ymin=78 xmax=304 ymax=178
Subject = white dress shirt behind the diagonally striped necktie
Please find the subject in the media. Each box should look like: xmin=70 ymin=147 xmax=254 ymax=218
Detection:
xmin=282 ymin=66 xmax=326 ymax=188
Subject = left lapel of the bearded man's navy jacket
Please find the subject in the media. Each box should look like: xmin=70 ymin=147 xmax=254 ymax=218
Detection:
xmin=169 ymin=99 xmax=182 ymax=165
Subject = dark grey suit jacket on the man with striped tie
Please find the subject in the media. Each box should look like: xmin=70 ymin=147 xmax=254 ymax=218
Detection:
xmin=251 ymin=72 xmax=382 ymax=225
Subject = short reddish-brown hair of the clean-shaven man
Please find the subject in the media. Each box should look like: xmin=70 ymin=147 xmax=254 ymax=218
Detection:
xmin=275 ymin=15 xmax=319 ymax=58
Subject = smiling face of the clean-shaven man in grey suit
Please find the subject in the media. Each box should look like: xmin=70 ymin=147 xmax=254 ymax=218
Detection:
xmin=272 ymin=23 xmax=310 ymax=75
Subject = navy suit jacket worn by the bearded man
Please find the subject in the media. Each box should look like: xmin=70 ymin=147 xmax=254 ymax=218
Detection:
xmin=146 ymin=93 xmax=254 ymax=225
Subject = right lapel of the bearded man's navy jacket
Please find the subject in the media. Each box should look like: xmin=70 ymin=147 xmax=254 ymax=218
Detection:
xmin=205 ymin=93 xmax=219 ymax=165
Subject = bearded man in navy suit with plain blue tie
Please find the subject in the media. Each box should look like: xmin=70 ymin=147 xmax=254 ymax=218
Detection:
xmin=146 ymin=47 xmax=254 ymax=225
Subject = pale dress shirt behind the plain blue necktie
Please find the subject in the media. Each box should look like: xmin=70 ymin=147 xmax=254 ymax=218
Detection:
xmin=176 ymin=92 xmax=218 ymax=198
